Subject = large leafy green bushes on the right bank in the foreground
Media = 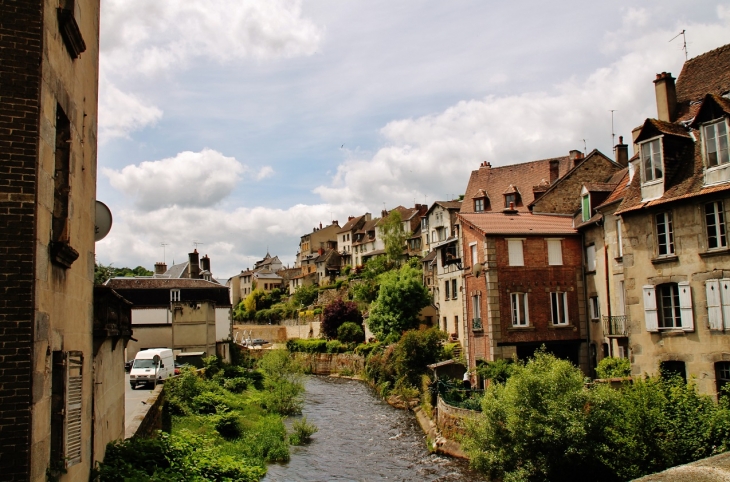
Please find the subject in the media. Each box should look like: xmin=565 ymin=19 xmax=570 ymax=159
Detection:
xmin=464 ymin=351 xmax=730 ymax=481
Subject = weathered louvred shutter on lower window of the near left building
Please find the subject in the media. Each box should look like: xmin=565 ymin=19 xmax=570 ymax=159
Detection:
xmin=64 ymin=351 xmax=84 ymax=467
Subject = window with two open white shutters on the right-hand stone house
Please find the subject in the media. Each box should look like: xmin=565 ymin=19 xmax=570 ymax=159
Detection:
xmin=643 ymin=281 xmax=694 ymax=332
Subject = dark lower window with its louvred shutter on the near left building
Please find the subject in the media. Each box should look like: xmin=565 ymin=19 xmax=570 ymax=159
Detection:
xmin=51 ymin=351 xmax=84 ymax=468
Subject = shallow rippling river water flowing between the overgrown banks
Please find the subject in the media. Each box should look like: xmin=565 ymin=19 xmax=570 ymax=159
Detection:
xmin=264 ymin=376 xmax=486 ymax=482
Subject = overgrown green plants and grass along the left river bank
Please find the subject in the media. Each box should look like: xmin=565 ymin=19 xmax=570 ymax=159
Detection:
xmin=97 ymin=350 xmax=317 ymax=482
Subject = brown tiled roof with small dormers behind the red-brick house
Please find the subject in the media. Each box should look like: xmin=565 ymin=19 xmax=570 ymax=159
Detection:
xmin=460 ymin=156 xmax=572 ymax=214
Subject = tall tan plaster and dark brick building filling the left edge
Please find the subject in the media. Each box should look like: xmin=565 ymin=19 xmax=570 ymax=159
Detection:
xmin=0 ymin=0 xmax=131 ymax=481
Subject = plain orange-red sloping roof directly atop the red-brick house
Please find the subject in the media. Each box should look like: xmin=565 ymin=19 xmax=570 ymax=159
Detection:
xmin=459 ymin=212 xmax=577 ymax=235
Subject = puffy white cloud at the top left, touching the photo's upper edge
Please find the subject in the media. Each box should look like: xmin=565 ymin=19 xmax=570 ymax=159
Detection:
xmin=101 ymin=0 xmax=323 ymax=75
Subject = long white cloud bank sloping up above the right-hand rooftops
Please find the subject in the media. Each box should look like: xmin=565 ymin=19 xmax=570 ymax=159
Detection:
xmin=314 ymin=9 xmax=730 ymax=206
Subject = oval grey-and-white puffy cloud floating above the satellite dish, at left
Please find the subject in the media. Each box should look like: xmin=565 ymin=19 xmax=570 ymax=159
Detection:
xmin=103 ymin=149 xmax=246 ymax=210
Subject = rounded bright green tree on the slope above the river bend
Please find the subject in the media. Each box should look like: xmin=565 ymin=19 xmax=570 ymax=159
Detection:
xmin=368 ymin=264 xmax=431 ymax=340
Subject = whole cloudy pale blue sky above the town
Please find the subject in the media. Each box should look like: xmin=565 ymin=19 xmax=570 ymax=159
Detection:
xmin=96 ymin=0 xmax=730 ymax=281
